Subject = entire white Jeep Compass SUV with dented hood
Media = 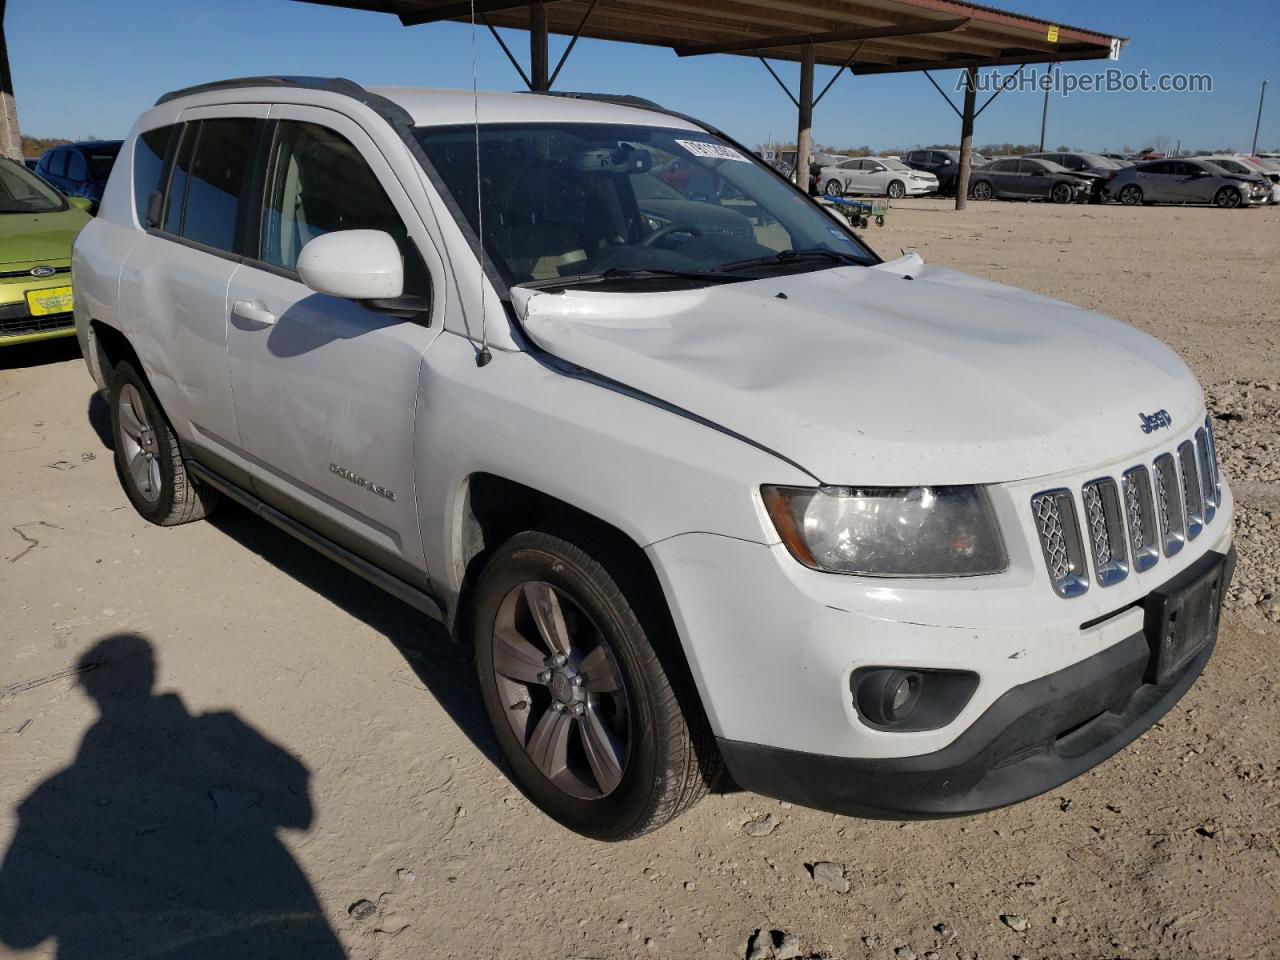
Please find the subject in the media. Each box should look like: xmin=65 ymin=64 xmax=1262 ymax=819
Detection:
xmin=73 ymin=77 xmax=1234 ymax=840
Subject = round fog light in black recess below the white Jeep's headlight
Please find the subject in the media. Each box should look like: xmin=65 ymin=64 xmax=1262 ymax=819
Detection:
xmin=850 ymin=667 xmax=978 ymax=732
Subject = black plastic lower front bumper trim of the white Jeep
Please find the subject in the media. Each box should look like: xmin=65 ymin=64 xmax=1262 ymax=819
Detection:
xmin=718 ymin=549 xmax=1235 ymax=819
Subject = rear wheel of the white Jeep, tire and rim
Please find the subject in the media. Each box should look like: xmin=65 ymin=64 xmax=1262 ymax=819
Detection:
xmin=110 ymin=361 xmax=218 ymax=526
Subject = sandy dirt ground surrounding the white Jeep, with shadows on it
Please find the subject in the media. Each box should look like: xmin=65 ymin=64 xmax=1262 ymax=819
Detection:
xmin=0 ymin=200 xmax=1280 ymax=960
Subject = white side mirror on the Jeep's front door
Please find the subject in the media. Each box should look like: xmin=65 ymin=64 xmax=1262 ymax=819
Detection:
xmin=298 ymin=230 xmax=404 ymax=300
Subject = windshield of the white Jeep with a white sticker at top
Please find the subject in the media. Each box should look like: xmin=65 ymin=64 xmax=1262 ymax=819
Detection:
xmin=415 ymin=123 xmax=877 ymax=284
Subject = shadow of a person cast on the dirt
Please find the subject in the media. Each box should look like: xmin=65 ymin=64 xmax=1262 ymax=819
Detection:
xmin=0 ymin=634 xmax=346 ymax=960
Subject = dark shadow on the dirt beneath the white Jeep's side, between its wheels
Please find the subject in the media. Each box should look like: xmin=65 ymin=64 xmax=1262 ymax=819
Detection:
xmin=210 ymin=498 xmax=506 ymax=773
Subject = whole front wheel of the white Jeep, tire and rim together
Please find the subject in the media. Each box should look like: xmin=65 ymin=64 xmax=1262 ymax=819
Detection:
xmin=472 ymin=530 xmax=721 ymax=841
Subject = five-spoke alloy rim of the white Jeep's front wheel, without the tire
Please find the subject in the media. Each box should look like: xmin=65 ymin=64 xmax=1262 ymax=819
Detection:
xmin=492 ymin=580 xmax=631 ymax=800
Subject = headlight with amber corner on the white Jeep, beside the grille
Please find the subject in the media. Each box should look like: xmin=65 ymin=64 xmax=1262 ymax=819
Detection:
xmin=760 ymin=486 xmax=1009 ymax=577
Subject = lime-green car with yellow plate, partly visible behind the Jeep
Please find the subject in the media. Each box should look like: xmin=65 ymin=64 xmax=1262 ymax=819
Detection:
xmin=0 ymin=157 xmax=90 ymax=347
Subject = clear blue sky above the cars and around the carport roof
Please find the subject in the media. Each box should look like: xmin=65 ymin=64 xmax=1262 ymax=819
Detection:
xmin=5 ymin=0 xmax=1280 ymax=150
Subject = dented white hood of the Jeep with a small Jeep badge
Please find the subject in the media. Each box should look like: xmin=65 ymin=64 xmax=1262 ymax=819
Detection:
xmin=512 ymin=255 xmax=1203 ymax=485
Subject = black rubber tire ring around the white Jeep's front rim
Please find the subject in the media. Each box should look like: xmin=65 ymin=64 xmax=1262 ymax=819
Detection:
xmin=471 ymin=532 xmax=666 ymax=840
